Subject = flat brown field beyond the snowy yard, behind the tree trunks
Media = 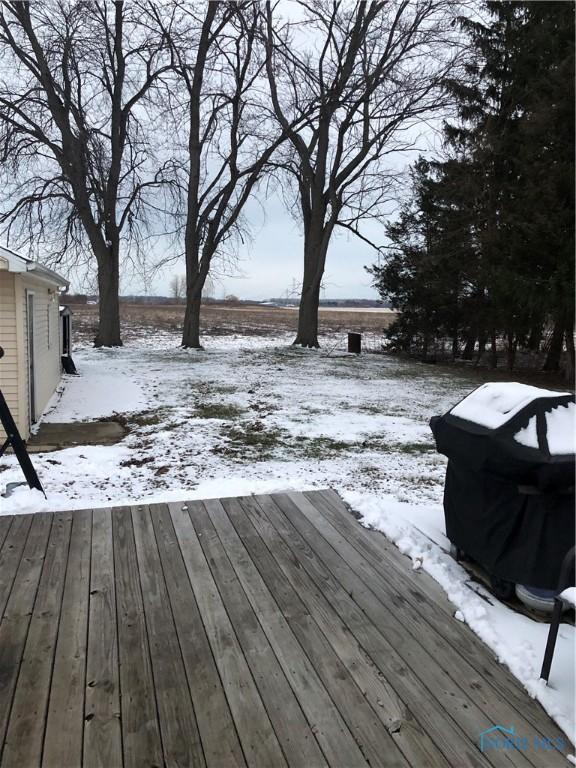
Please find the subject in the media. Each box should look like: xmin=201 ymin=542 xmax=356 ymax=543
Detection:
xmin=71 ymin=304 xmax=395 ymax=341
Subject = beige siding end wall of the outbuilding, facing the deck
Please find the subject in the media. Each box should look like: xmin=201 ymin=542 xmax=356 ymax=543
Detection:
xmin=0 ymin=269 xmax=20 ymax=443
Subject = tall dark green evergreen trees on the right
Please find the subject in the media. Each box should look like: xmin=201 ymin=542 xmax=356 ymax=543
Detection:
xmin=370 ymin=2 xmax=574 ymax=380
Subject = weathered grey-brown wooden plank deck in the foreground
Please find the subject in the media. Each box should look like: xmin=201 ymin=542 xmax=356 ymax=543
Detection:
xmin=0 ymin=491 xmax=568 ymax=768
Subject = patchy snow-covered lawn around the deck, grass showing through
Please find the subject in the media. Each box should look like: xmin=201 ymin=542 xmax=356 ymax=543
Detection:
xmin=0 ymin=332 xmax=575 ymax=739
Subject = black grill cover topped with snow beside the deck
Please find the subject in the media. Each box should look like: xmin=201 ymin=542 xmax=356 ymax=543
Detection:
xmin=430 ymin=383 xmax=576 ymax=589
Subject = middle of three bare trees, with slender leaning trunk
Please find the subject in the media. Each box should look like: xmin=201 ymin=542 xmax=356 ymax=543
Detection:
xmin=156 ymin=2 xmax=301 ymax=348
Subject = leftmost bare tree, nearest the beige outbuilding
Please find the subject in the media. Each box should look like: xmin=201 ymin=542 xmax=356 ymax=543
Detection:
xmin=0 ymin=0 xmax=171 ymax=346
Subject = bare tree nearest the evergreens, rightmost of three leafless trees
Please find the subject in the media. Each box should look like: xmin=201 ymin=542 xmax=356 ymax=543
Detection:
xmin=265 ymin=0 xmax=460 ymax=347
